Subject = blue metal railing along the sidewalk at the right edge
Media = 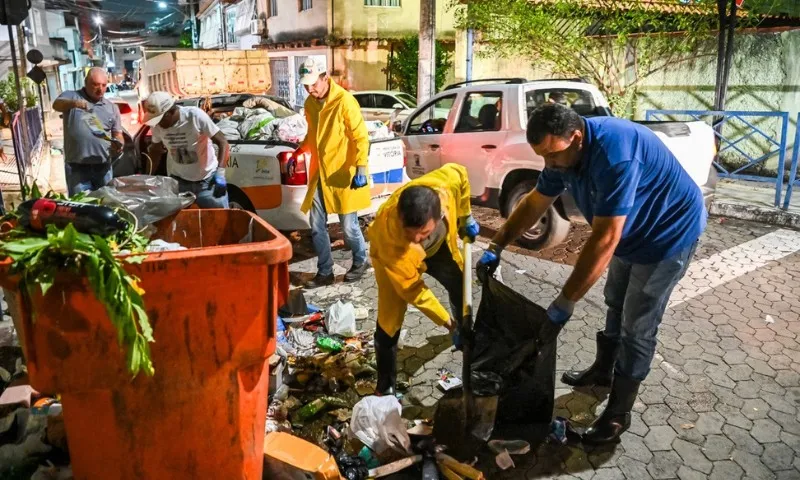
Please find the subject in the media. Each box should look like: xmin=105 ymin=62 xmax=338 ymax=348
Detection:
xmin=646 ymin=110 xmax=798 ymax=209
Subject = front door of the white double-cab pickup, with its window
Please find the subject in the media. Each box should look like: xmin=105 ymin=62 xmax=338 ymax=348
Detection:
xmin=403 ymin=93 xmax=457 ymax=178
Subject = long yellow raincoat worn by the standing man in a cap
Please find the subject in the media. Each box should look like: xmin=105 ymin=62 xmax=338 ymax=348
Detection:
xmin=300 ymin=80 xmax=371 ymax=214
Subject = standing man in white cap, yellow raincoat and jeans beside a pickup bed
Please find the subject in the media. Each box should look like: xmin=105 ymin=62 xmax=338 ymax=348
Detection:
xmin=299 ymin=59 xmax=370 ymax=288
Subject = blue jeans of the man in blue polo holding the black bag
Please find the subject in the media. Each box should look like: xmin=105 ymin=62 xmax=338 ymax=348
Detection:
xmin=604 ymin=242 xmax=697 ymax=381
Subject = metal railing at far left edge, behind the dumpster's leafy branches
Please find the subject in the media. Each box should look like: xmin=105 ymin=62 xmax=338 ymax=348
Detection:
xmin=0 ymin=107 xmax=44 ymax=191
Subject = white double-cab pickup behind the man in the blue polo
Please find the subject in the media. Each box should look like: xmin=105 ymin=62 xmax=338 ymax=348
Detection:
xmin=402 ymin=79 xmax=717 ymax=249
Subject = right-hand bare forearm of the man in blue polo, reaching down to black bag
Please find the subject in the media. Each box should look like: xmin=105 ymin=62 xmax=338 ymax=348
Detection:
xmin=562 ymin=217 xmax=627 ymax=302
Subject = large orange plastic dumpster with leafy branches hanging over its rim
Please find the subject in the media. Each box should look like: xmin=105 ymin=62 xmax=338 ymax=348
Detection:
xmin=0 ymin=210 xmax=292 ymax=480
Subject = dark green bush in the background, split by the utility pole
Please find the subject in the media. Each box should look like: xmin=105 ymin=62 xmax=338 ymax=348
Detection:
xmin=384 ymin=36 xmax=453 ymax=97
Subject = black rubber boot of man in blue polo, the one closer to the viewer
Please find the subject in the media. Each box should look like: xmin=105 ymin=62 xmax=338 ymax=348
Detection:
xmin=582 ymin=375 xmax=641 ymax=445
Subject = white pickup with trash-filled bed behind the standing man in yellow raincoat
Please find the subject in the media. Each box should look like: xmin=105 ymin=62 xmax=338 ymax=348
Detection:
xmin=114 ymin=93 xmax=408 ymax=231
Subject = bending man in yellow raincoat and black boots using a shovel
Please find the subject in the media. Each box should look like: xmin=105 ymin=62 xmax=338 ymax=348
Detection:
xmin=369 ymin=164 xmax=480 ymax=395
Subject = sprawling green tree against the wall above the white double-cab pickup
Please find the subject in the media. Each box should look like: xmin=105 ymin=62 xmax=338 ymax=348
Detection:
xmin=455 ymin=0 xmax=775 ymax=116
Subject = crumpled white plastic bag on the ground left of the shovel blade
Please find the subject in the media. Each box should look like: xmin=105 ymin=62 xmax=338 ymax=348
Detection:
xmin=350 ymin=395 xmax=411 ymax=455
